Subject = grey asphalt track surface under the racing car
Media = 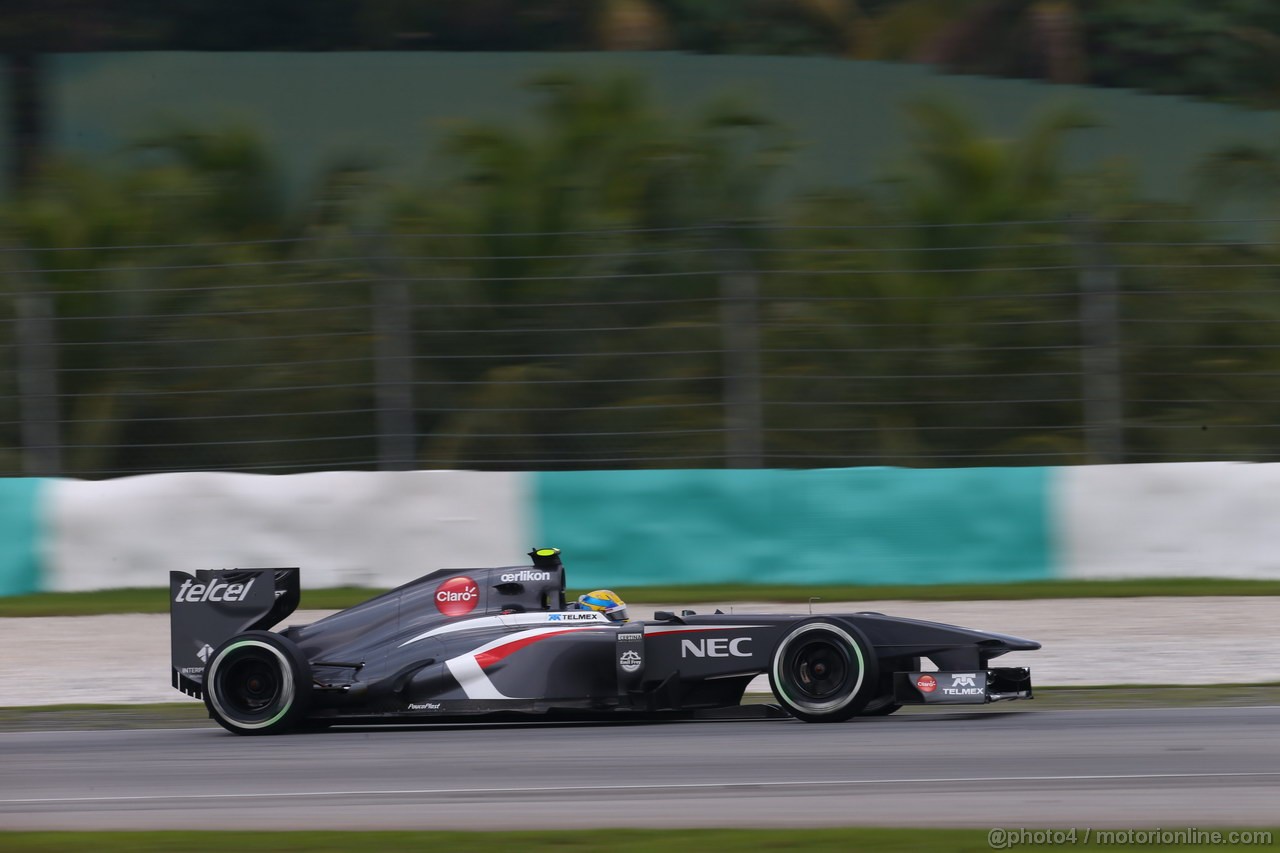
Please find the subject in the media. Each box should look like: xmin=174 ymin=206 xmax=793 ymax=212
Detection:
xmin=0 ymin=706 xmax=1280 ymax=830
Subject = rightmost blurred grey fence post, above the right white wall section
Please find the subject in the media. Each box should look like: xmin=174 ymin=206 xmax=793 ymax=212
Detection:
xmin=1076 ymin=219 xmax=1124 ymax=465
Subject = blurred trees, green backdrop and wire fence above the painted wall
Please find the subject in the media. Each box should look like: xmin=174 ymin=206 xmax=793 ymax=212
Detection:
xmin=0 ymin=0 xmax=1280 ymax=479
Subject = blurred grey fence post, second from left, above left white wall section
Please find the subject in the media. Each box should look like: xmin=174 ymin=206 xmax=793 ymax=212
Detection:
xmin=369 ymin=235 xmax=416 ymax=471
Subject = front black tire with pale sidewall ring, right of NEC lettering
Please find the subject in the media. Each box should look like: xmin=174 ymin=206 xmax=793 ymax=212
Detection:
xmin=769 ymin=617 xmax=879 ymax=722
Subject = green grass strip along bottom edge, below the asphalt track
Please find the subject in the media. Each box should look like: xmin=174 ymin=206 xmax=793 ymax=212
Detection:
xmin=0 ymin=818 xmax=1280 ymax=853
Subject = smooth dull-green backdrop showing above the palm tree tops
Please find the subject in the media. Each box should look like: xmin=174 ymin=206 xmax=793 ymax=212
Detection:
xmin=49 ymin=51 xmax=1280 ymax=199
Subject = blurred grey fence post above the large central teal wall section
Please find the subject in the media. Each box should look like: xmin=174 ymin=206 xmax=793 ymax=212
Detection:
xmin=717 ymin=225 xmax=764 ymax=467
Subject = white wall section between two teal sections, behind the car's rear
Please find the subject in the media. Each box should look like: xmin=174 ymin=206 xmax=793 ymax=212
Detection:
xmin=44 ymin=471 xmax=534 ymax=590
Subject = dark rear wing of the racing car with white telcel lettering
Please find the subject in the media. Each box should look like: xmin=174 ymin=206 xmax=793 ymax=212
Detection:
xmin=169 ymin=569 xmax=302 ymax=699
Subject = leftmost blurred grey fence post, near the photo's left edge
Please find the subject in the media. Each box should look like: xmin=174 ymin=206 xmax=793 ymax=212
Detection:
xmin=15 ymin=285 xmax=63 ymax=476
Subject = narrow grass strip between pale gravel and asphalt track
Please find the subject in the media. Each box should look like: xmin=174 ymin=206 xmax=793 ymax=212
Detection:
xmin=0 ymin=683 xmax=1280 ymax=727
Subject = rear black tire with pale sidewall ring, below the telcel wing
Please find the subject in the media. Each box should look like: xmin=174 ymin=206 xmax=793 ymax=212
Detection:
xmin=205 ymin=631 xmax=311 ymax=735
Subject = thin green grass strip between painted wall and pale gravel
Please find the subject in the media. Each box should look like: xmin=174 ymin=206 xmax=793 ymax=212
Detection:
xmin=0 ymin=578 xmax=1280 ymax=617
